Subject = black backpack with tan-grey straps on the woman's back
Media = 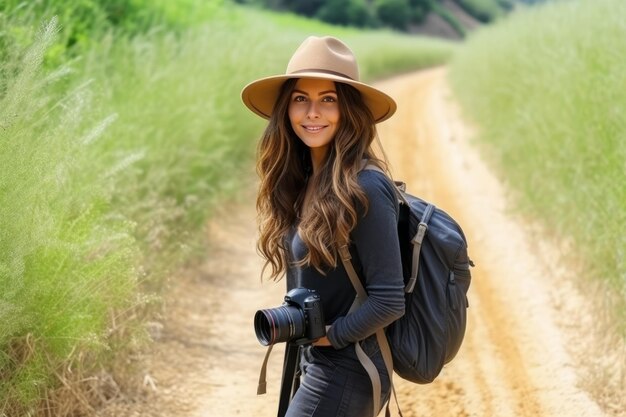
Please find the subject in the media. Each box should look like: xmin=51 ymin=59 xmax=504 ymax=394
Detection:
xmin=340 ymin=166 xmax=473 ymax=415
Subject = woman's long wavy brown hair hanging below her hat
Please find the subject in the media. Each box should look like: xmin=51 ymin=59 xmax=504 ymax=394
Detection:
xmin=257 ymin=79 xmax=387 ymax=280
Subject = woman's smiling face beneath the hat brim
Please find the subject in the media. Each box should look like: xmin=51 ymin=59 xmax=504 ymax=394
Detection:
xmin=289 ymin=78 xmax=339 ymax=156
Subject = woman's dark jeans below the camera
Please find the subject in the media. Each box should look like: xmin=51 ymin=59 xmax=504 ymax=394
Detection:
xmin=286 ymin=336 xmax=390 ymax=417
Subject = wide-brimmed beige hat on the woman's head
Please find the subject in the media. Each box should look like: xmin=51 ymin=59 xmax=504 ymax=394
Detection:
xmin=241 ymin=36 xmax=396 ymax=123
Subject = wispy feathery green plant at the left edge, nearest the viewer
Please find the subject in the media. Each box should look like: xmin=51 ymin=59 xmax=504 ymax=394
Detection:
xmin=0 ymin=20 xmax=136 ymax=412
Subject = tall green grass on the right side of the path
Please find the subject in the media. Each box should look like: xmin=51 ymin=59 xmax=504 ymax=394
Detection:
xmin=451 ymin=0 xmax=626 ymax=405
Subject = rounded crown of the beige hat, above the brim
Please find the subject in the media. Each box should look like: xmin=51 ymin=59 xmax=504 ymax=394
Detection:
xmin=287 ymin=36 xmax=359 ymax=81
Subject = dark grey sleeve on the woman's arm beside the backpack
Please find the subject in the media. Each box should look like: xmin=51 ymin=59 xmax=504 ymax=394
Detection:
xmin=327 ymin=170 xmax=404 ymax=349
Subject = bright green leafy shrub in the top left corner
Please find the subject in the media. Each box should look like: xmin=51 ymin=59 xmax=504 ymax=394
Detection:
xmin=0 ymin=0 xmax=226 ymax=67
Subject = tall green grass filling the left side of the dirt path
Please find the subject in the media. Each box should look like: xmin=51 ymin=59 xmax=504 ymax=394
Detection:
xmin=0 ymin=0 xmax=452 ymax=415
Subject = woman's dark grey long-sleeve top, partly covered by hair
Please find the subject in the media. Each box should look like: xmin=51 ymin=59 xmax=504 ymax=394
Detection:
xmin=287 ymin=170 xmax=404 ymax=349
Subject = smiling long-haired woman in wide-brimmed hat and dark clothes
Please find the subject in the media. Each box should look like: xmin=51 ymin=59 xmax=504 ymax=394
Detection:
xmin=242 ymin=37 xmax=404 ymax=417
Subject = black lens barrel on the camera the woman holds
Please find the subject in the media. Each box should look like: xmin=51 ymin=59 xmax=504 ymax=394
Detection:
xmin=254 ymin=305 xmax=305 ymax=346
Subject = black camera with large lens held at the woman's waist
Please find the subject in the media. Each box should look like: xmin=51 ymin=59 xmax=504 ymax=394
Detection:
xmin=254 ymin=288 xmax=326 ymax=346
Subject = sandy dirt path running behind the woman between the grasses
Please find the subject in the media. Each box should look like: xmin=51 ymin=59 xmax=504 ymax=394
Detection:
xmin=102 ymin=69 xmax=604 ymax=417
